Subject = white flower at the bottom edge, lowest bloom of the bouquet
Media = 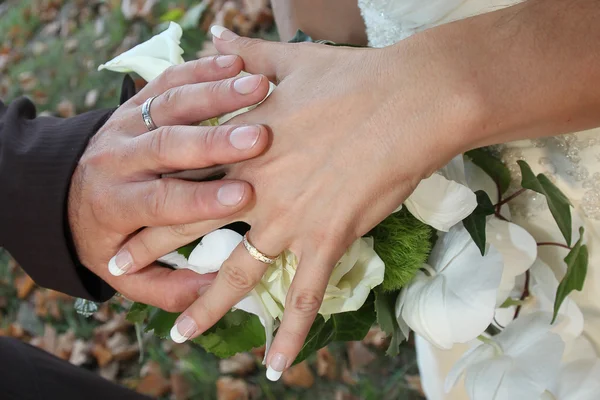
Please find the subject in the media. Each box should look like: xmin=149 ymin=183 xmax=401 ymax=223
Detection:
xmin=446 ymin=313 xmax=565 ymax=400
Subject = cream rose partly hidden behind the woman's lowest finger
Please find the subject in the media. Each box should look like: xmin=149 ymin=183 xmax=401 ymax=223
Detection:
xmin=263 ymin=238 xmax=385 ymax=318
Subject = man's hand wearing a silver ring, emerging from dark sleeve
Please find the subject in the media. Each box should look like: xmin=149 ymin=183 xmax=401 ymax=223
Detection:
xmin=68 ymin=56 xmax=269 ymax=312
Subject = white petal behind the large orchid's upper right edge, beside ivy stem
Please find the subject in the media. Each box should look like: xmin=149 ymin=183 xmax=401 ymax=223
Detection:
xmin=485 ymin=218 xmax=537 ymax=306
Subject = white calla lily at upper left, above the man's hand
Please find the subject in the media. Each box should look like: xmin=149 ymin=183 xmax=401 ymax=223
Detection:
xmin=98 ymin=22 xmax=184 ymax=82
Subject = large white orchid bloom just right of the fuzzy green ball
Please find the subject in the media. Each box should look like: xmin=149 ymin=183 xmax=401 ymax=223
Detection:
xmin=396 ymin=225 xmax=502 ymax=349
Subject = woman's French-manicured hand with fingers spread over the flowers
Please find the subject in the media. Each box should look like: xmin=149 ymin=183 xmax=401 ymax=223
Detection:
xmin=124 ymin=29 xmax=480 ymax=371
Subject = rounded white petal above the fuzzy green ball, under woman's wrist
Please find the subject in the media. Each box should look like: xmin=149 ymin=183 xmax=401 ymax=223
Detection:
xmin=404 ymin=174 xmax=477 ymax=232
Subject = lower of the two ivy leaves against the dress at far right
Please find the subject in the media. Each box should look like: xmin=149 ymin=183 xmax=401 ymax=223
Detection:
xmin=552 ymin=228 xmax=588 ymax=323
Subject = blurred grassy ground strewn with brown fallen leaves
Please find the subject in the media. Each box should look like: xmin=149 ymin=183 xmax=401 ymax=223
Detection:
xmin=0 ymin=0 xmax=422 ymax=400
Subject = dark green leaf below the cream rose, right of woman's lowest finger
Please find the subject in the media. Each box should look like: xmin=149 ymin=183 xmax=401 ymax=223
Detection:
xmin=294 ymin=295 xmax=376 ymax=364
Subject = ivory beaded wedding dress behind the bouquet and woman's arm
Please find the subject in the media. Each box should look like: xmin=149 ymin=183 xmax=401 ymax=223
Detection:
xmin=358 ymin=0 xmax=600 ymax=400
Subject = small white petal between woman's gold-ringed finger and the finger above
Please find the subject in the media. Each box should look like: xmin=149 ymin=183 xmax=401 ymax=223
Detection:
xmin=188 ymin=229 xmax=242 ymax=274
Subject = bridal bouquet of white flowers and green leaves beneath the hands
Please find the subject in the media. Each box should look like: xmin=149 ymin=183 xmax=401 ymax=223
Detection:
xmin=95 ymin=23 xmax=600 ymax=399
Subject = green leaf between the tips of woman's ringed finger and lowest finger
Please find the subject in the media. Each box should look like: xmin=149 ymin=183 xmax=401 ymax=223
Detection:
xmin=192 ymin=310 xmax=266 ymax=358
